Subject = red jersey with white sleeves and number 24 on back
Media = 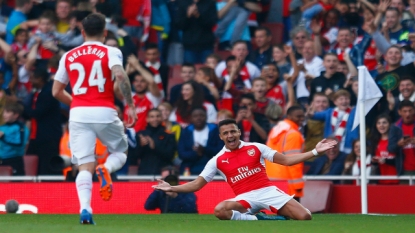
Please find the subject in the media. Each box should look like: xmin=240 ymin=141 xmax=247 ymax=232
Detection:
xmin=55 ymin=41 xmax=123 ymax=123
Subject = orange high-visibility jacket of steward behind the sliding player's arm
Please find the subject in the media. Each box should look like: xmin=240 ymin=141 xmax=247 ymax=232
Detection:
xmin=265 ymin=119 xmax=304 ymax=197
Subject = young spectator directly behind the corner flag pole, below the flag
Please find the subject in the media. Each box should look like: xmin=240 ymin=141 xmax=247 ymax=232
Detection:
xmin=341 ymin=139 xmax=372 ymax=184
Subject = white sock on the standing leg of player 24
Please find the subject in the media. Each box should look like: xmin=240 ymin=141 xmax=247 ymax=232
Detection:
xmin=76 ymin=170 xmax=92 ymax=213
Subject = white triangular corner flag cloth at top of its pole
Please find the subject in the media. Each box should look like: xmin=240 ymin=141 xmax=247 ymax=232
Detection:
xmin=352 ymin=66 xmax=383 ymax=130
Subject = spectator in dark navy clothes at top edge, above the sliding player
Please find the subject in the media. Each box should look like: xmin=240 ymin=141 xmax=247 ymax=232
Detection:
xmin=176 ymin=0 xmax=218 ymax=63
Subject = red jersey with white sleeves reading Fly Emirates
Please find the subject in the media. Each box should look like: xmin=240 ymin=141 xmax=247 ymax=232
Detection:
xmin=200 ymin=141 xmax=277 ymax=195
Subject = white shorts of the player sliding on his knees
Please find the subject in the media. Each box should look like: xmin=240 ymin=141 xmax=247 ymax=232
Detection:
xmin=227 ymin=186 xmax=294 ymax=214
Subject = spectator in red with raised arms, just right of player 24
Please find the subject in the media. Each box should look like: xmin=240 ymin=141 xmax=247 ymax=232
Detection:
xmin=124 ymin=55 xmax=163 ymax=132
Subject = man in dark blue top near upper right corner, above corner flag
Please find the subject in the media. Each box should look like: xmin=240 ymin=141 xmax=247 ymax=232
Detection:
xmin=385 ymin=8 xmax=409 ymax=46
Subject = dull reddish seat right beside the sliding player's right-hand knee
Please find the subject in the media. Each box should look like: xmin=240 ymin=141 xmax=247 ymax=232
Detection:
xmin=300 ymin=181 xmax=333 ymax=213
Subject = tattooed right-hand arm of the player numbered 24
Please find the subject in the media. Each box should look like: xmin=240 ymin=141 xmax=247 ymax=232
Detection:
xmin=112 ymin=65 xmax=137 ymax=128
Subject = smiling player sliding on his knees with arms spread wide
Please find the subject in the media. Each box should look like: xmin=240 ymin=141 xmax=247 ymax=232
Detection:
xmin=153 ymin=119 xmax=337 ymax=220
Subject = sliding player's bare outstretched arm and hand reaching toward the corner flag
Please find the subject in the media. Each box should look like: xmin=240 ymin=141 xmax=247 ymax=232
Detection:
xmin=273 ymin=139 xmax=337 ymax=166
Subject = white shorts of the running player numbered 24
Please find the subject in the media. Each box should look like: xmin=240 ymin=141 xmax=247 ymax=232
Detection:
xmin=69 ymin=119 xmax=128 ymax=165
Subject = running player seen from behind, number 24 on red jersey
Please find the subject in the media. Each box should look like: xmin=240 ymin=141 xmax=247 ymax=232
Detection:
xmin=52 ymin=14 xmax=137 ymax=224
